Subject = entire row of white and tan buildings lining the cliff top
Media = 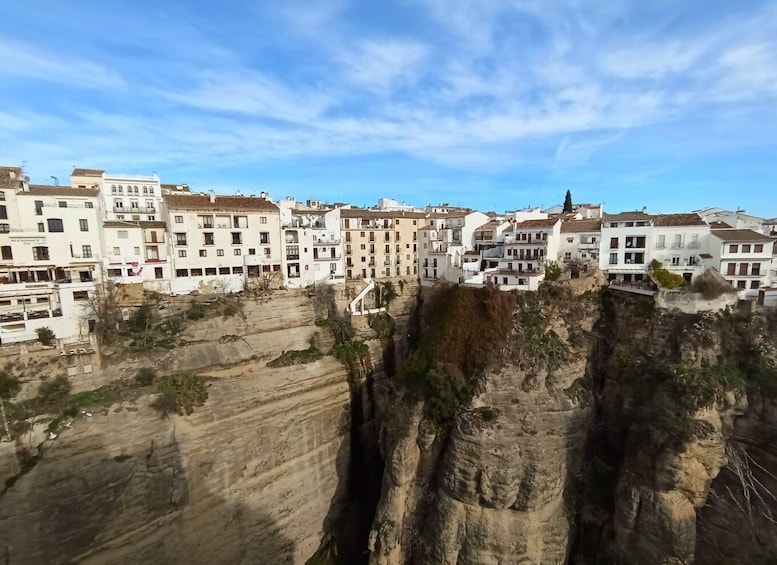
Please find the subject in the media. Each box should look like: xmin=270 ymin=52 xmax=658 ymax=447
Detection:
xmin=0 ymin=167 xmax=777 ymax=343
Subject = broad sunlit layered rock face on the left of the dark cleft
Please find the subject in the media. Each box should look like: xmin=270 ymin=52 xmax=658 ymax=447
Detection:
xmin=0 ymin=294 xmax=350 ymax=564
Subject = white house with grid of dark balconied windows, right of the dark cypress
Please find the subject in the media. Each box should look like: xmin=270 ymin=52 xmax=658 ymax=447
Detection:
xmin=599 ymin=211 xmax=653 ymax=282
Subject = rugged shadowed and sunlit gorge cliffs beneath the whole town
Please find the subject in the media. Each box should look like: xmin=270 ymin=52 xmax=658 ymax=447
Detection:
xmin=0 ymin=278 xmax=777 ymax=565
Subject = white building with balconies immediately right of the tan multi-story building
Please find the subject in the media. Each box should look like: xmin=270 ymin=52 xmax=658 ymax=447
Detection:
xmin=418 ymin=211 xmax=488 ymax=285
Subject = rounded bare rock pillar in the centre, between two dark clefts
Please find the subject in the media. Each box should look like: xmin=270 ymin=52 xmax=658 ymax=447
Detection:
xmin=370 ymin=284 xmax=597 ymax=565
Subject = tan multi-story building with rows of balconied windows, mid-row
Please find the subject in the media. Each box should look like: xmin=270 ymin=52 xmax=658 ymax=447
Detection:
xmin=340 ymin=208 xmax=426 ymax=279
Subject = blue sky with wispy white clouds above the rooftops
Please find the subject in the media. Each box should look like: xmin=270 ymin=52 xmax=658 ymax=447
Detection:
xmin=0 ymin=0 xmax=777 ymax=216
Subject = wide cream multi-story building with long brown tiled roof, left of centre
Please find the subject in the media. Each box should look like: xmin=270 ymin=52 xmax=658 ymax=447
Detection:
xmin=164 ymin=193 xmax=283 ymax=294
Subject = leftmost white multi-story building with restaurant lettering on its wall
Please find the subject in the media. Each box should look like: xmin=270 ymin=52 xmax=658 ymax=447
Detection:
xmin=0 ymin=167 xmax=100 ymax=343
